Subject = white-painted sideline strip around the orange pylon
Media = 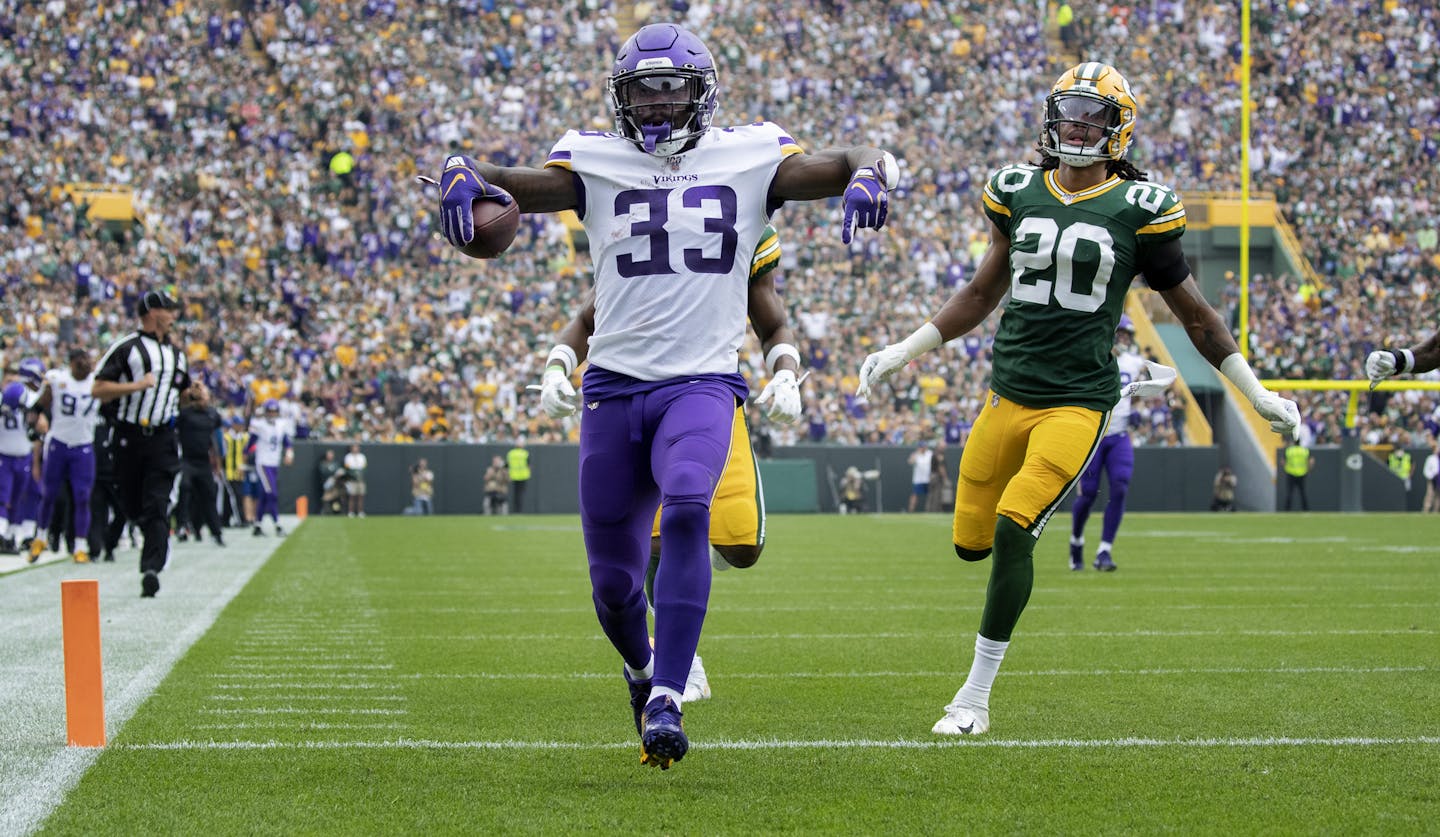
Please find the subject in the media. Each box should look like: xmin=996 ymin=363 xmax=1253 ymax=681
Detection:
xmin=0 ymin=516 xmax=298 ymax=834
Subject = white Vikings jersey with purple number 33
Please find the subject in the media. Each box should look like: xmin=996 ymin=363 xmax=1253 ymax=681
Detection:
xmin=546 ymin=122 xmax=804 ymax=380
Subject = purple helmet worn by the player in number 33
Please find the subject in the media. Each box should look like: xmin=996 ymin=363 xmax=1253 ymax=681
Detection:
xmin=606 ymin=23 xmax=720 ymax=157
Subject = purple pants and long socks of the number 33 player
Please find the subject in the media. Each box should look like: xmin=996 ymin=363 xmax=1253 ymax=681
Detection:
xmin=580 ymin=380 xmax=736 ymax=691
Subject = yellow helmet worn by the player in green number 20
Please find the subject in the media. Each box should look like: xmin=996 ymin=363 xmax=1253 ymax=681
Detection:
xmin=1040 ymin=61 xmax=1136 ymax=167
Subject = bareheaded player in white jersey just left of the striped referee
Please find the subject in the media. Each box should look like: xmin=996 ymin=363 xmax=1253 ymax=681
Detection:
xmin=30 ymin=349 xmax=99 ymax=563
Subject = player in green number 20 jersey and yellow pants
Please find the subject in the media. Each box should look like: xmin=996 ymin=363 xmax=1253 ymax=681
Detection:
xmin=858 ymin=62 xmax=1300 ymax=735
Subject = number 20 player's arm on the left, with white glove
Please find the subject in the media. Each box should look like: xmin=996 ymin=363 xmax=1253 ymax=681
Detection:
xmin=855 ymin=223 xmax=1009 ymax=398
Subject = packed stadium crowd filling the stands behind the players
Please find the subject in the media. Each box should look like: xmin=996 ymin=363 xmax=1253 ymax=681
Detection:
xmin=0 ymin=0 xmax=1440 ymax=445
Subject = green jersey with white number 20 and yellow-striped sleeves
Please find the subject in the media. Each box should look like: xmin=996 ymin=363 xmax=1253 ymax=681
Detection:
xmin=984 ymin=164 xmax=1185 ymax=412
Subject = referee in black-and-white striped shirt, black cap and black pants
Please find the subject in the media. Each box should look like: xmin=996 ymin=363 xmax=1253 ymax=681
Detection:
xmin=92 ymin=291 xmax=190 ymax=598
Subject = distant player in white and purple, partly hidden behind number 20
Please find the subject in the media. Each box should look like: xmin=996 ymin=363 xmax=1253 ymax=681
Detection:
xmin=1070 ymin=314 xmax=1174 ymax=572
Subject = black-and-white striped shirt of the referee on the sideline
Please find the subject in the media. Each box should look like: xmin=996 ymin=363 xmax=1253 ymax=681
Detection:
xmin=95 ymin=331 xmax=190 ymax=428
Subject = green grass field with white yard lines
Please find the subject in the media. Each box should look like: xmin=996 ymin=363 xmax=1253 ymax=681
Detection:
xmin=30 ymin=514 xmax=1440 ymax=834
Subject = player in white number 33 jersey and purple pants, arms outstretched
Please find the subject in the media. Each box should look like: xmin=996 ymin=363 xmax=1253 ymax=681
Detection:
xmin=439 ymin=23 xmax=899 ymax=768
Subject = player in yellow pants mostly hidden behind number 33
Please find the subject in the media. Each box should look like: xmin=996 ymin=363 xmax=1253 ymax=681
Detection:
xmin=537 ymin=226 xmax=802 ymax=703
